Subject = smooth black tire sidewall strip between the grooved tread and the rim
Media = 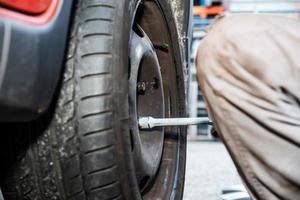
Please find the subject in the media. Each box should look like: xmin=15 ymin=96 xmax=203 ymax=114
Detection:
xmin=112 ymin=0 xmax=142 ymax=200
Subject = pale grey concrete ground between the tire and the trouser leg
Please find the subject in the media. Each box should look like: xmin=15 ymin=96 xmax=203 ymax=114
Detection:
xmin=183 ymin=141 xmax=241 ymax=200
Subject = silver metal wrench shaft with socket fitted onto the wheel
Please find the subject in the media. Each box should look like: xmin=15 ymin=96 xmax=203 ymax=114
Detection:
xmin=138 ymin=117 xmax=212 ymax=129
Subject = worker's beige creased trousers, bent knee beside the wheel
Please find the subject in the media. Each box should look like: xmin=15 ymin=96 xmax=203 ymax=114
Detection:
xmin=196 ymin=14 xmax=300 ymax=200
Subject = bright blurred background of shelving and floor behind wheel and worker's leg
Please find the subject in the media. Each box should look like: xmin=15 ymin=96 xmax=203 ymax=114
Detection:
xmin=184 ymin=0 xmax=300 ymax=200
